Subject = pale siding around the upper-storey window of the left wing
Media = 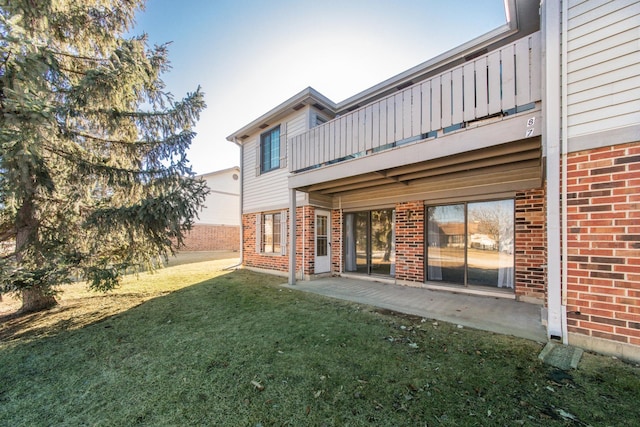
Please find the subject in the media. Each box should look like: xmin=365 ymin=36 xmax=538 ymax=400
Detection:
xmin=242 ymin=109 xmax=308 ymax=212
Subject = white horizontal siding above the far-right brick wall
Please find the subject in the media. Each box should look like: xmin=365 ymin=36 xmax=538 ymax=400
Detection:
xmin=567 ymin=0 xmax=640 ymax=138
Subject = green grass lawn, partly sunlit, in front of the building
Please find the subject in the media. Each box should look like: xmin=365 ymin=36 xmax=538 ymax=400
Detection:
xmin=0 ymin=259 xmax=640 ymax=426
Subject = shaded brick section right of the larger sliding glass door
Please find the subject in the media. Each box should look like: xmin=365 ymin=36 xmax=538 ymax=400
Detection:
xmin=515 ymin=189 xmax=547 ymax=301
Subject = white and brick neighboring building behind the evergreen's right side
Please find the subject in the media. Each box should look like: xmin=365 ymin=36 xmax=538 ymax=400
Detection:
xmin=181 ymin=166 xmax=240 ymax=251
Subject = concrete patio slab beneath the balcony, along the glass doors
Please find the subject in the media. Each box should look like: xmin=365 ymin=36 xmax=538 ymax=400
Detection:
xmin=284 ymin=277 xmax=547 ymax=342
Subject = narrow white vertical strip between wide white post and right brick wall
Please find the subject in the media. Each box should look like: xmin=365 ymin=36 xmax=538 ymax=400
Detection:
xmin=560 ymin=0 xmax=569 ymax=345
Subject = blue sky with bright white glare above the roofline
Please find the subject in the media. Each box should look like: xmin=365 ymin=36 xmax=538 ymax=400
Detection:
xmin=131 ymin=0 xmax=506 ymax=174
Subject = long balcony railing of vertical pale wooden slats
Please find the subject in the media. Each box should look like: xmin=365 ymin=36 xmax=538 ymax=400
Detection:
xmin=288 ymin=32 xmax=541 ymax=172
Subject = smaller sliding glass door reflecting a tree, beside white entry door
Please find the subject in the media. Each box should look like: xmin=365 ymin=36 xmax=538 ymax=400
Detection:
xmin=345 ymin=209 xmax=395 ymax=276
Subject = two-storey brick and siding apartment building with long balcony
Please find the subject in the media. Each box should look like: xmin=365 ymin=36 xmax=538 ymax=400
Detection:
xmin=228 ymin=0 xmax=640 ymax=360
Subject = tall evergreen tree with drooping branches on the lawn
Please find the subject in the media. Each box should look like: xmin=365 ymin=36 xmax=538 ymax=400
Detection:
xmin=0 ymin=0 xmax=208 ymax=311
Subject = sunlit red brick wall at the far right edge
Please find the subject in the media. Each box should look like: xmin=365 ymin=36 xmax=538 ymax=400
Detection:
xmin=567 ymin=143 xmax=640 ymax=345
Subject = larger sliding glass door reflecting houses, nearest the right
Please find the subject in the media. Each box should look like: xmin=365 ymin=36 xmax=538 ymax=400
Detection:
xmin=427 ymin=200 xmax=515 ymax=289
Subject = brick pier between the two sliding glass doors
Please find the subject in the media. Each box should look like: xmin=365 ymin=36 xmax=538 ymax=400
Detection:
xmin=396 ymin=201 xmax=425 ymax=283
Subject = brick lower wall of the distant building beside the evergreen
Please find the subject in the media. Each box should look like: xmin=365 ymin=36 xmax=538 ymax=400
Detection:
xmin=180 ymin=224 xmax=240 ymax=251
